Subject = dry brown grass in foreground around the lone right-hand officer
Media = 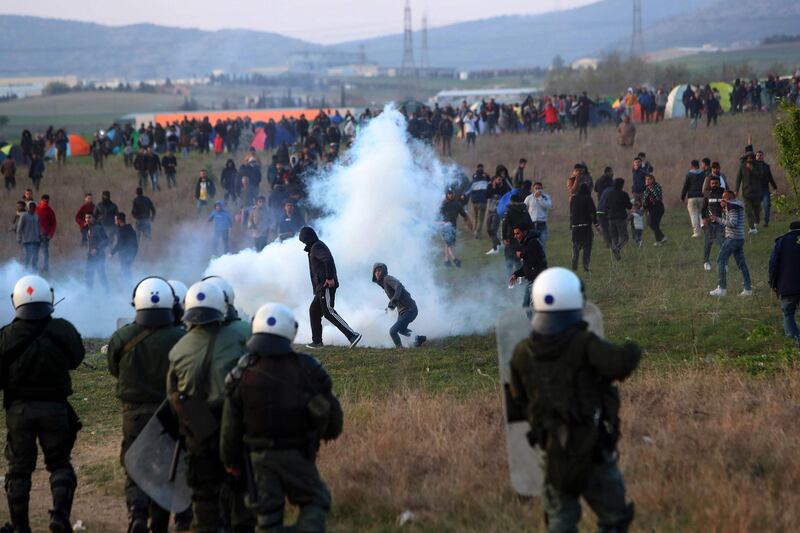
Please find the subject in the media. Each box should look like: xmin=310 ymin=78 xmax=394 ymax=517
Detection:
xmin=321 ymin=366 xmax=800 ymax=532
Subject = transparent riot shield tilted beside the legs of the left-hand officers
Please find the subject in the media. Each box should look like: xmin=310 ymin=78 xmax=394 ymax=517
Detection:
xmin=125 ymin=401 xmax=192 ymax=513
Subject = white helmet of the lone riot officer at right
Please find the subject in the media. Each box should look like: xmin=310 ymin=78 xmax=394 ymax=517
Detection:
xmin=531 ymin=267 xmax=585 ymax=335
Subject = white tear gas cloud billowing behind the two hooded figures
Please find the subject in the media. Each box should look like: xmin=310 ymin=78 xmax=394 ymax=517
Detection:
xmin=0 ymin=106 xmax=510 ymax=346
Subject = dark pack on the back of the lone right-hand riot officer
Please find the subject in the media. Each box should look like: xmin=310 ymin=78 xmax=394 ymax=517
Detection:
xmin=528 ymin=330 xmax=601 ymax=496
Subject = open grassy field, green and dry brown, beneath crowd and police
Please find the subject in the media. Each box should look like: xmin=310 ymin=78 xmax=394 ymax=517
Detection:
xmin=0 ymin=111 xmax=800 ymax=532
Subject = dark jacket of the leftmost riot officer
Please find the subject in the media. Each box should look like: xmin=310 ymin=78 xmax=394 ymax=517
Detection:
xmin=0 ymin=316 xmax=86 ymax=407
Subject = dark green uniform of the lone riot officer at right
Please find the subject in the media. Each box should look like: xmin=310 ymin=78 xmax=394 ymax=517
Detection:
xmin=511 ymin=322 xmax=641 ymax=533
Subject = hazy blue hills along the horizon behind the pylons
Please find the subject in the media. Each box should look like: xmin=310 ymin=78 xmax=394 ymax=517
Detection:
xmin=0 ymin=0 xmax=800 ymax=80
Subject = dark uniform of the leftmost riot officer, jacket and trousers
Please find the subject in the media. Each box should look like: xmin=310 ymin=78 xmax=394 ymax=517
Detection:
xmin=0 ymin=316 xmax=85 ymax=533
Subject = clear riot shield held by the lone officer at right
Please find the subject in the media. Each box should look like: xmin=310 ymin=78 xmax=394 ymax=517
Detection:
xmin=495 ymin=302 xmax=603 ymax=497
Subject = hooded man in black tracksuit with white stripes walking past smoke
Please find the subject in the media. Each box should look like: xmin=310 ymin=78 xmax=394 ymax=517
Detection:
xmin=300 ymin=226 xmax=361 ymax=348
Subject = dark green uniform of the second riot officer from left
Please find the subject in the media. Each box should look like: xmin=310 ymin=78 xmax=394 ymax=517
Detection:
xmin=108 ymin=322 xmax=184 ymax=533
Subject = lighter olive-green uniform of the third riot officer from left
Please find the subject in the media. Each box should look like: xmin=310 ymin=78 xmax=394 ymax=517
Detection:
xmin=167 ymin=324 xmax=254 ymax=533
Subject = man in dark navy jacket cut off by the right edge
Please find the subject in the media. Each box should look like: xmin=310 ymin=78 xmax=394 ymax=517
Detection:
xmin=769 ymin=220 xmax=800 ymax=346
